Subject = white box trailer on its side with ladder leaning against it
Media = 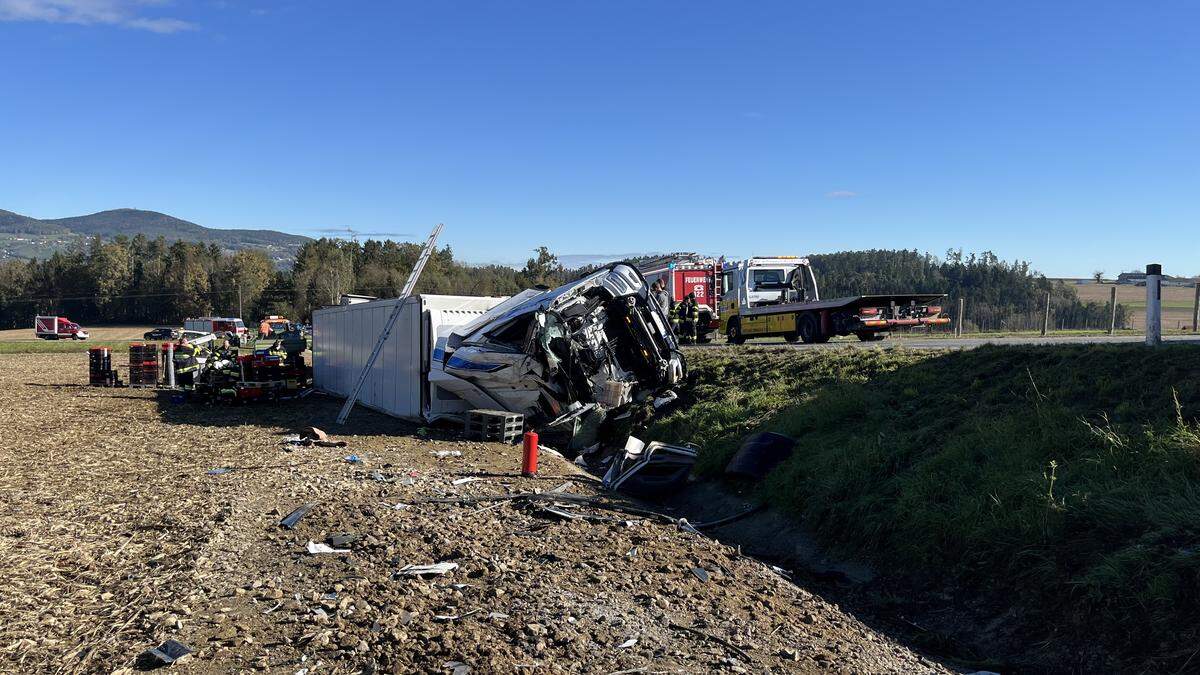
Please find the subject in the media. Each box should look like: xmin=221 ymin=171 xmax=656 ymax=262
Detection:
xmin=312 ymin=295 xmax=504 ymax=420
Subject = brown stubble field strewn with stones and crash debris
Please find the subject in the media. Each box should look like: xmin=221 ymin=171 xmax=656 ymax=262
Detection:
xmin=0 ymin=354 xmax=944 ymax=674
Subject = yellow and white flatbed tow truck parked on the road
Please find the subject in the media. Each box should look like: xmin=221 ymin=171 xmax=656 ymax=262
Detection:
xmin=720 ymin=256 xmax=950 ymax=345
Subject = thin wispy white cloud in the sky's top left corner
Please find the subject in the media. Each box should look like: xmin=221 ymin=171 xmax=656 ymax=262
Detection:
xmin=0 ymin=0 xmax=196 ymax=32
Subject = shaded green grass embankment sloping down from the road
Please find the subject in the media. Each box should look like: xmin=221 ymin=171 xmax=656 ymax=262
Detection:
xmin=646 ymin=345 xmax=1200 ymax=668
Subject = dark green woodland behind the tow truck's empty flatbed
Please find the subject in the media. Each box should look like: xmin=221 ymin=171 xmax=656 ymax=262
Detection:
xmin=809 ymin=250 xmax=1129 ymax=330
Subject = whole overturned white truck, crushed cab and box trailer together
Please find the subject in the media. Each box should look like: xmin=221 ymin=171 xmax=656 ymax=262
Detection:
xmin=313 ymin=263 xmax=684 ymax=420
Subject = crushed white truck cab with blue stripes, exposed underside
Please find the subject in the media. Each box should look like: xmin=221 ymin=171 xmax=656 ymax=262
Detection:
xmin=430 ymin=263 xmax=685 ymax=420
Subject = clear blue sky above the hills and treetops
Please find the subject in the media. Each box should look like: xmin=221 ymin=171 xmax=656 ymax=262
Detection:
xmin=0 ymin=0 xmax=1200 ymax=276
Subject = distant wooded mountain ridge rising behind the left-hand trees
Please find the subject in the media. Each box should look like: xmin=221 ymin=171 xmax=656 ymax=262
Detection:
xmin=0 ymin=209 xmax=310 ymax=264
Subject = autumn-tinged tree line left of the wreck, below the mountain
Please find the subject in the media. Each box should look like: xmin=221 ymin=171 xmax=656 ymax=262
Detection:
xmin=0 ymin=235 xmax=566 ymax=328
